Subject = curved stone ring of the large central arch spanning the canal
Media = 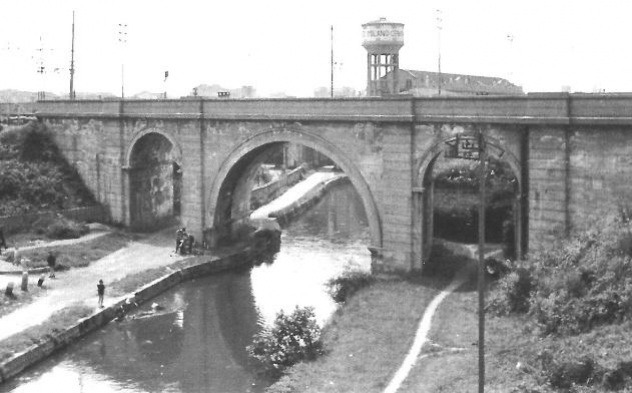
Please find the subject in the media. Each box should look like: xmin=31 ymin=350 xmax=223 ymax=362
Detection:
xmin=206 ymin=128 xmax=382 ymax=252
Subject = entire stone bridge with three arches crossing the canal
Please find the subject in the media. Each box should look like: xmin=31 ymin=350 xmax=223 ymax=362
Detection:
xmin=0 ymin=93 xmax=632 ymax=270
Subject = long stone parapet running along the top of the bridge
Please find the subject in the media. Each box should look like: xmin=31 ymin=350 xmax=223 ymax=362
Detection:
xmin=22 ymin=93 xmax=632 ymax=125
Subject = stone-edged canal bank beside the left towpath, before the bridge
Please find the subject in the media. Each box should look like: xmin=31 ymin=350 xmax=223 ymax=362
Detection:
xmin=0 ymin=247 xmax=256 ymax=383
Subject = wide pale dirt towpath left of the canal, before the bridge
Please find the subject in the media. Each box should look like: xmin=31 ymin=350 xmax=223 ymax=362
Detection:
xmin=0 ymin=230 xmax=184 ymax=340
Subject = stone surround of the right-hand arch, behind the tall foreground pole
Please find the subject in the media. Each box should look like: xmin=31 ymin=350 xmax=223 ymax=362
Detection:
xmin=413 ymin=131 xmax=527 ymax=270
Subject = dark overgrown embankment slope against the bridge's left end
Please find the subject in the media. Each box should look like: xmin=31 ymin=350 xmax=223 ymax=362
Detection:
xmin=0 ymin=122 xmax=95 ymax=216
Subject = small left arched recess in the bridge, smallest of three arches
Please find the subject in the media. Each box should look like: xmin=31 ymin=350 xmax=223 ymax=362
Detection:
xmin=123 ymin=127 xmax=183 ymax=230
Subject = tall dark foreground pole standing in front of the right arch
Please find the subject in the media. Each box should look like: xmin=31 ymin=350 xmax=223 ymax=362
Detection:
xmin=478 ymin=129 xmax=487 ymax=393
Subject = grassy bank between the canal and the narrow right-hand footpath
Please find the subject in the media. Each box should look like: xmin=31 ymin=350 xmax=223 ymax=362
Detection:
xmin=268 ymin=247 xmax=465 ymax=393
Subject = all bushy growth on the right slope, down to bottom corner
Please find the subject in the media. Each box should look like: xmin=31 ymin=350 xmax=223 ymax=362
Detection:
xmin=487 ymin=214 xmax=632 ymax=392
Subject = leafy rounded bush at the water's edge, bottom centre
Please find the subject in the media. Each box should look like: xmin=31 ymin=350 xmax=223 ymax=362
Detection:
xmin=247 ymin=306 xmax=323 ymax=378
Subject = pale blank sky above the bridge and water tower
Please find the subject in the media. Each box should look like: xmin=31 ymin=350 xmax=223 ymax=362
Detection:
xmin=0 ymin=0 xmax=632 ymax=97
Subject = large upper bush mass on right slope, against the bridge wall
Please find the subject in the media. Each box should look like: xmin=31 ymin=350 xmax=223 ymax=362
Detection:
xmin=490 ymin=214 xmax=632 ymax=334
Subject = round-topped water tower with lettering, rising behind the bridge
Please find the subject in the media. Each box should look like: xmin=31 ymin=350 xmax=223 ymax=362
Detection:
xmin=362 ymin=18 xmax=404 ymax=96
